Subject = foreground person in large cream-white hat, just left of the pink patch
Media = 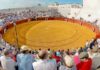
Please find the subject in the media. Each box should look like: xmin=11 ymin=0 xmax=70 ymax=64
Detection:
xmin=59 ymin=55 xmax=77 ymax=70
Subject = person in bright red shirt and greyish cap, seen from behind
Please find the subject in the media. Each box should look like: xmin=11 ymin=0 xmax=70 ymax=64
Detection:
xmin=77 ymin=52 xmax=92 ymax=70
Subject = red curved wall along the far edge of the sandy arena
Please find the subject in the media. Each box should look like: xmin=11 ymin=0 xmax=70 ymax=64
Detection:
xmin=0 ymin=17 xmax=100 ymax=38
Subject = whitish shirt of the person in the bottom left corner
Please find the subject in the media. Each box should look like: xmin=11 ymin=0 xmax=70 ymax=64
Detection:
xmin=0 ymin=56 xmax=15 ymax=70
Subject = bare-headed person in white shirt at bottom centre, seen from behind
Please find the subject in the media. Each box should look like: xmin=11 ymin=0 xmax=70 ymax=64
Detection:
xmin=33 ymin=50 xmax=57 ymax=70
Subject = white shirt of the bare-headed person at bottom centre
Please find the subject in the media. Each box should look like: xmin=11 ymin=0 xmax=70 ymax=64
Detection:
xmin=32 ymin=60 xmax=57 ymax=70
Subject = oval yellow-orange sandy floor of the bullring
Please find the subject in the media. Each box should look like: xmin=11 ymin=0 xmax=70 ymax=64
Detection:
xmin=3 ymin=20 xmax=95 ymax=50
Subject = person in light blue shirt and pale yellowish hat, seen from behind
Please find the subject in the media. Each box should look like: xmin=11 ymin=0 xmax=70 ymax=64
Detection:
xmin=17 ymin=45 xmax=34 ymax=70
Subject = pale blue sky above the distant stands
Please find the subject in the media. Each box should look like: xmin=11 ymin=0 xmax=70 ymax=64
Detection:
xmin=0 ymin=0 xmax=82 ymax=9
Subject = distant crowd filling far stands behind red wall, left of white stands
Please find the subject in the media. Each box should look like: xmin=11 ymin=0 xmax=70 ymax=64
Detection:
xmin=0 ymin=7 xmax=61 ymax=23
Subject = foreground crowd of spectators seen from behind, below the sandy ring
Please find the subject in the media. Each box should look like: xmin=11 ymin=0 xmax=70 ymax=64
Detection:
xmin=0 ymin=39 xmax=100 ymax=70
